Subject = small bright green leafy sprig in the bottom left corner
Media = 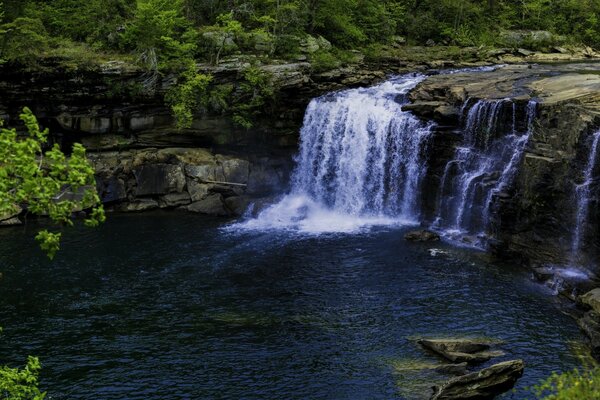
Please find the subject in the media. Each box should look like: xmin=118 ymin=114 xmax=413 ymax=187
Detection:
xmin=0 ymin=356 xmax=46 ymax=400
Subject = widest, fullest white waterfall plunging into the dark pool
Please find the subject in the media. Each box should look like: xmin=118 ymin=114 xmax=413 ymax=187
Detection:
xmin=238 ymin=75 xmax=431 ymax=232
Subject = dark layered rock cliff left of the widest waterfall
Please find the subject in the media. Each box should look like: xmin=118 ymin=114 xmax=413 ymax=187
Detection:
xmin=0 ymin=57 xmax=386 ymax=216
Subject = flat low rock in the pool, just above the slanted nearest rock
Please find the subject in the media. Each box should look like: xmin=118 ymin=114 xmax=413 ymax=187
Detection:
xmin=417 ymin=339 xmax=504 ymax=364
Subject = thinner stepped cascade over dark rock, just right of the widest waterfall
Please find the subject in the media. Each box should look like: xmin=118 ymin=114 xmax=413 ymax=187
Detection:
xmin=434 ymin=99 xmax=536 ymax=244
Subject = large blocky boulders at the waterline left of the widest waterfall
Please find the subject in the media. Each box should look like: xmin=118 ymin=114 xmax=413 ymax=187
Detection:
xmin=89 ymin=148 xmax=291 ymax=216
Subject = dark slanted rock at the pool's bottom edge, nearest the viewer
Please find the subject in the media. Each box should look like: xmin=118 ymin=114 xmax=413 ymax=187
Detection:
xmin=431 ymin=360 xmax=525 ymax=400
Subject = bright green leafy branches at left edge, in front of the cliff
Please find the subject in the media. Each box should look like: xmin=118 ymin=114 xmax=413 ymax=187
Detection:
xmin=0 ymin=108 xmax=105 ymax=258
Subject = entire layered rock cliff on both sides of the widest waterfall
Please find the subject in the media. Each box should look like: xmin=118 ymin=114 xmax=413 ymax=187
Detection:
xmin=0 ymin=59 xmax=600 ymax=263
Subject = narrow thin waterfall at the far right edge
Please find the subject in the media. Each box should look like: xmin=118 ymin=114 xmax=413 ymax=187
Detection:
xmin=571 ymin=131 xmax=600 ymax=263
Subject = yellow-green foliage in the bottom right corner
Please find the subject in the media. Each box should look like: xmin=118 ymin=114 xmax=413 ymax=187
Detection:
xmin=533 ymin=368 xmax=600 ymax=400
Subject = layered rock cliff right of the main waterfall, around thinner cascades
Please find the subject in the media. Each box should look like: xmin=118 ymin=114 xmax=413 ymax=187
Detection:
xmin=408 ymin=64 xmax=600 ymax=263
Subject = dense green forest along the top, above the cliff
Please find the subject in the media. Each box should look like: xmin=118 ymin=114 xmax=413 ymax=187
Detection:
xmin=0 ymin=0 xmax=600 ymax=69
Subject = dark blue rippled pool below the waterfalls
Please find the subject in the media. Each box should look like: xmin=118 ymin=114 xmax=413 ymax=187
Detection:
xmin=0 ymin=212 xmax=582 ymax=400
